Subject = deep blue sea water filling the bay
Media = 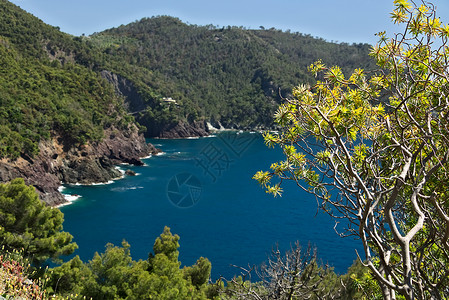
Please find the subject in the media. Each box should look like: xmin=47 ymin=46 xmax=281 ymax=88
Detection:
xmin=61 ymin=133 xmax=361 ymax=280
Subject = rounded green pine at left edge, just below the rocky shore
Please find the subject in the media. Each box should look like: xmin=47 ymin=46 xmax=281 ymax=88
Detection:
xmin=0 ymin=178 xmax=77 ymax=265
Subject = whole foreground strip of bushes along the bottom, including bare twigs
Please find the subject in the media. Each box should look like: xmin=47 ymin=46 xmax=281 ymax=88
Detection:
xmin=0 ymin=179 xmax=378 ymax=300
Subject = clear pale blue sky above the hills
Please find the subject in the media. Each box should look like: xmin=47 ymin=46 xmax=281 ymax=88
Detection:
xmin=11 ymin=0 xmax=449 ymax=44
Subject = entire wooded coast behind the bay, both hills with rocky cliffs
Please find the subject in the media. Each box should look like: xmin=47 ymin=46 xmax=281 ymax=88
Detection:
xmin=0 ymin=0 xmax=374 ymax=205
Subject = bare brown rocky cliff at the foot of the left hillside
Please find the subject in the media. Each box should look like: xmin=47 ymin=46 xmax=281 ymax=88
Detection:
xmin=0 ymin=126 xmax=157 ymax=206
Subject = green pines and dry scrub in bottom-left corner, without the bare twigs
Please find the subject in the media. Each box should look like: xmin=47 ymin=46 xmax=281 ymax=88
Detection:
xmin=0 ymin=178 xmax=217 ymax=299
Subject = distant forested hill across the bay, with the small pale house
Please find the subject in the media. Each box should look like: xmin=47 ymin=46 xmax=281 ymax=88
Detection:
xmin=90 ymin=16 xmax=374 ymax=135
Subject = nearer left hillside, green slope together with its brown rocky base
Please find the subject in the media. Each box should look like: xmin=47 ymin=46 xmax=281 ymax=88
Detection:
xmin=0 ymin=0 xmax=155 ymax=205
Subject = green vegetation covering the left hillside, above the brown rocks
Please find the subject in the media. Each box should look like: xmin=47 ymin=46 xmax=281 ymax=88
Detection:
xmin=0 ymin=0 xmax=132 ymax=159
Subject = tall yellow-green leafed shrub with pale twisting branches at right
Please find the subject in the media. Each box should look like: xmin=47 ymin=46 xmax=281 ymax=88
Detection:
xmin=254 ymin=0 xmax=449 ymax=299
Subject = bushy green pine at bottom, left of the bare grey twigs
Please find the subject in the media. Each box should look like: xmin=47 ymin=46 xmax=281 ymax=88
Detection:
xmin=48 ymin=227 xmax=217 ymax=300
